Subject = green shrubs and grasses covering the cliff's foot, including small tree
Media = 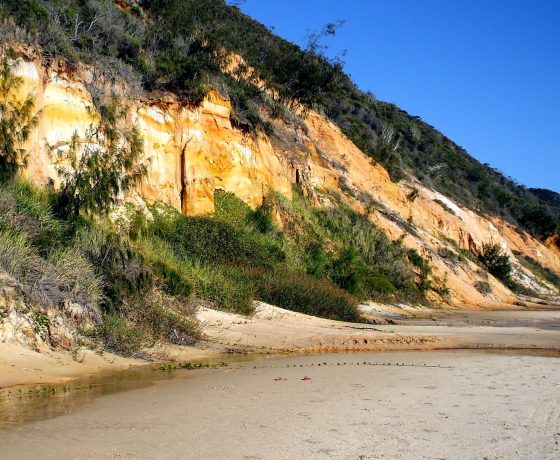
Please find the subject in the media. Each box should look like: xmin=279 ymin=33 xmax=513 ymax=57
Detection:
xmin=0 ymin=47 xmax=436 ymax=344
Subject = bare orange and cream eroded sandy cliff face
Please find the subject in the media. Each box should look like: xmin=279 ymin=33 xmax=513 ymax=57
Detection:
xmin=12 ymin=56 xmax=560 ymax=307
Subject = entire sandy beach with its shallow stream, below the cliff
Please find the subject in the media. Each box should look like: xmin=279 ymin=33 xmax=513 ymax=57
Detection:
xmin=0 ymin=304 xmax=560 ymax=460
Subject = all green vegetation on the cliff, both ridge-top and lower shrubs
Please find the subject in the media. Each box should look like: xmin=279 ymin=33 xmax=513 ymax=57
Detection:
xmin=0 ymin=0 xmax=560 ymax=354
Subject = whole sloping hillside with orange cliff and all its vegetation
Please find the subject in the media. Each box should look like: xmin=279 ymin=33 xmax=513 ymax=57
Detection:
xmin=0 ymin=0 xmax=560 ymax=353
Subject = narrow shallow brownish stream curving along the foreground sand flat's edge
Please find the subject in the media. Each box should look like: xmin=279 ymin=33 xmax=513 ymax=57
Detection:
xmin=0 ymin=350 xmax=560 ymax=430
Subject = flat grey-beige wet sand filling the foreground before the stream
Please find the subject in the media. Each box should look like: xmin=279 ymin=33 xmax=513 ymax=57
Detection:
xmin=0 ymin=351 xmax=560 ymax=459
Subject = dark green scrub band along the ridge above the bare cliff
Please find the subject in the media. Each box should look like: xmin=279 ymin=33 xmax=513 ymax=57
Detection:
xmin=0 ymin=0 xmax=560 ymax=238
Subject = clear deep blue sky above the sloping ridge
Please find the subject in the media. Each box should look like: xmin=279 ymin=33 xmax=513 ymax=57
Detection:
xmin=236 ymin=0 xmax=560 ymax=192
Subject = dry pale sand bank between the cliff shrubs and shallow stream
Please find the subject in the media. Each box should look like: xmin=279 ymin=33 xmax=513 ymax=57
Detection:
xmin=0 ymin=304 xmax=560 ymax=390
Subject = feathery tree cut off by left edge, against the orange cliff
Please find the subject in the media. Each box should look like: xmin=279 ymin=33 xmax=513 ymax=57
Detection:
xmin=0 ymin=50 xmax=38 ymax=179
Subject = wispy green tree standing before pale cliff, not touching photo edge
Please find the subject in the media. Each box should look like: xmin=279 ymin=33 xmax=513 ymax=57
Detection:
xmin=53 ymin=95 xmax=147 ymax=219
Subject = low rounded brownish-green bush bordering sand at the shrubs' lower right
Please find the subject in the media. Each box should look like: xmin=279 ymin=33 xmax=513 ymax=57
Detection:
xmin=257 ymin=271 xmax=360 ymax=322
